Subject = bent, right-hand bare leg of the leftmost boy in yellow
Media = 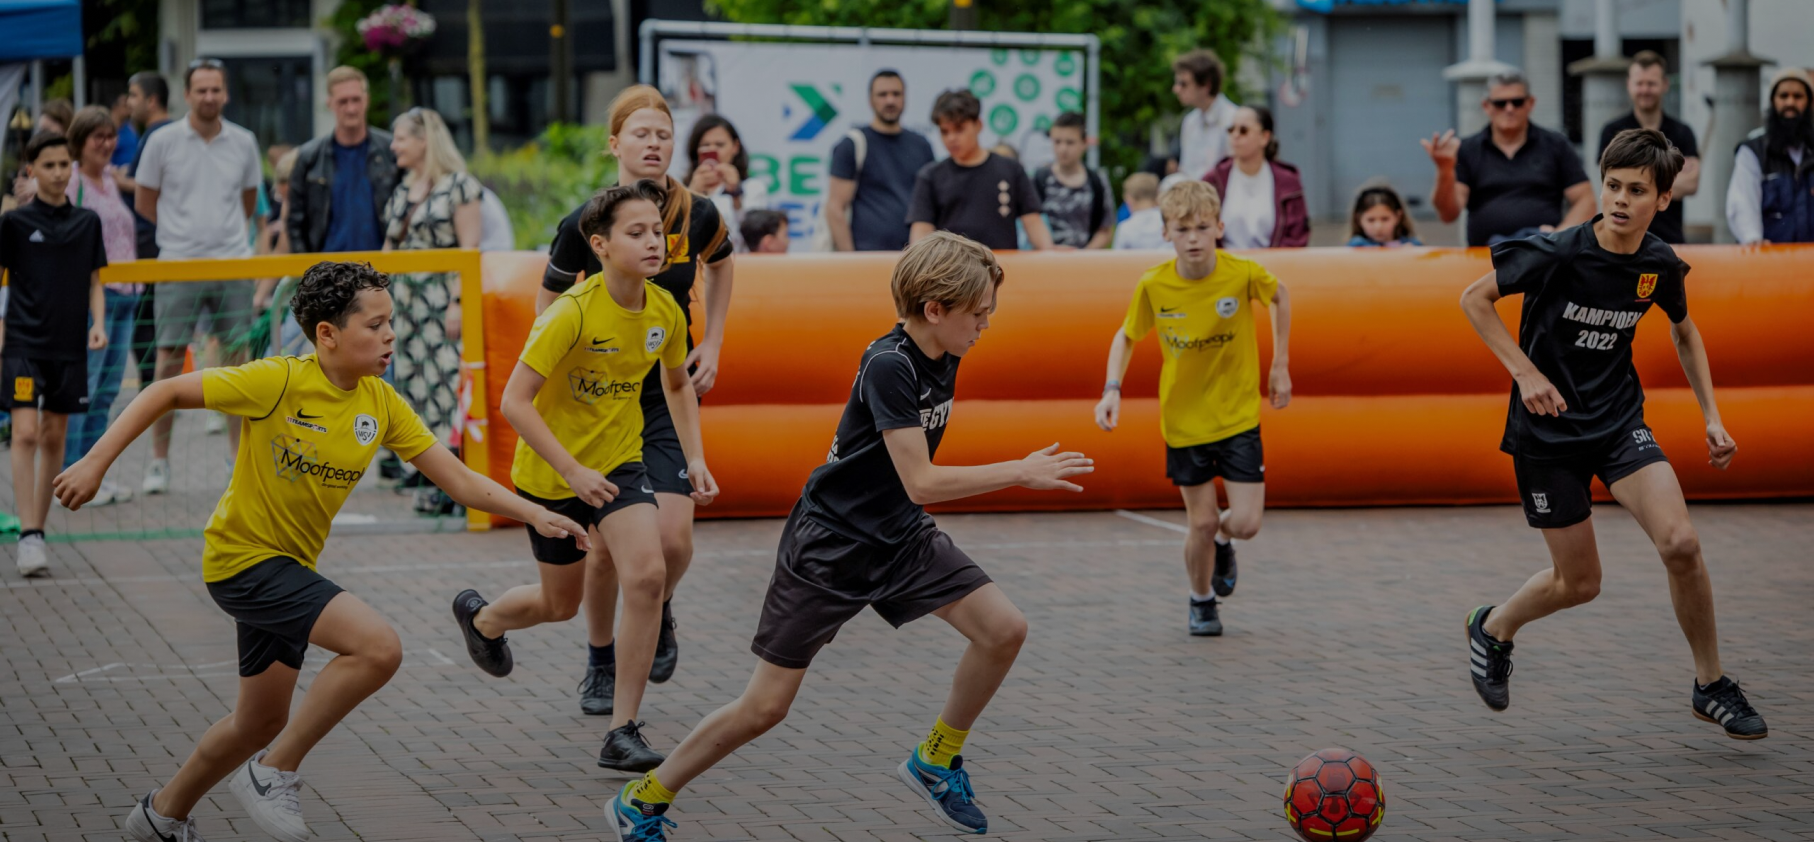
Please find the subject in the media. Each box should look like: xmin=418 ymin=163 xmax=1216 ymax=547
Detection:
xmin=263 ymin=592 xmax=403 ymax=773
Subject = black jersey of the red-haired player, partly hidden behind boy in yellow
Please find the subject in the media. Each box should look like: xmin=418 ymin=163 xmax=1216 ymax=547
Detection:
xmin=542 ymin=185 xmax=733 ymax=406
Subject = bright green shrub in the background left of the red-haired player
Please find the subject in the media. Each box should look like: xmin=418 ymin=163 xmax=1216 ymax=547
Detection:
xmin=468 ymin=123 xmax=617 ymax=250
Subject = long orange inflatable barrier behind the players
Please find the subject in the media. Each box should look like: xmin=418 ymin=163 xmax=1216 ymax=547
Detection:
xmin=484 ymin=247 xmax=1814 ymax=517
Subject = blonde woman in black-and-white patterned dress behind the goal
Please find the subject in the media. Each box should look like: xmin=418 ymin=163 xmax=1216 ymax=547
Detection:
xmin=385 ymin=107 xmax=484 ymax=514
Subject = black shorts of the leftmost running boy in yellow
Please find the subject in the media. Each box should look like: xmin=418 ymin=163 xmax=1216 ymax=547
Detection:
xmin=209 ymin=555 xmax=343 ymax=679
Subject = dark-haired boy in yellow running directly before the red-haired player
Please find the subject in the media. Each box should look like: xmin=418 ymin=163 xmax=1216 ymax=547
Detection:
xmin=454 ymin=181 xmax=718 ymax=771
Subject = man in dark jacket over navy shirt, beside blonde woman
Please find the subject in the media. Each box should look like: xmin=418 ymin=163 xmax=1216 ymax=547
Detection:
xmin=285 ymin=67 xmax=399 ymax=254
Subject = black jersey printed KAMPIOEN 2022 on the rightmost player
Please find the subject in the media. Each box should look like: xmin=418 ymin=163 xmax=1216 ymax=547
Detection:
xmin=1493 ymin=216 xmax=1689 ymax=457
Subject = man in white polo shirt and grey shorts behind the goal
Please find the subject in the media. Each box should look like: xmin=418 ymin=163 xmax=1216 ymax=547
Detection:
xmin=134 ymin=58 xmax=263 ymax=494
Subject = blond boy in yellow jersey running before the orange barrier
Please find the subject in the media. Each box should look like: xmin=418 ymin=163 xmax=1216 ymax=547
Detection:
xmin=1096 ymin=181 xmax=1292 ymax=637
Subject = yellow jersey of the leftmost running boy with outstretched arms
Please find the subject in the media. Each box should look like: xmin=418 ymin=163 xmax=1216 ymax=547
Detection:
xmin=201 ymin=354 xmax=435 ymax=583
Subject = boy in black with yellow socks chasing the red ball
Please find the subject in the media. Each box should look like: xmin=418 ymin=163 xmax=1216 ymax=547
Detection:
xmin=604 ymin=232 xmax=1092 ymax=842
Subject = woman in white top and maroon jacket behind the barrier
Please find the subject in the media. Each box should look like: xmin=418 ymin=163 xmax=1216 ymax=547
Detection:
xmin=1203 ymin=105 xmax=1310 ymax=249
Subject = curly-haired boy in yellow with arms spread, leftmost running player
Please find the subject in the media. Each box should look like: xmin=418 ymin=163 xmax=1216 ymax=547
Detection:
xmin=54 ymin=263 xmax=584 ymax=842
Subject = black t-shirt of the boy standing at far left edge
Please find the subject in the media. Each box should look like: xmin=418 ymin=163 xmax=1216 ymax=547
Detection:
xmin=0 ymin=200 xmax=107 ymax=361
